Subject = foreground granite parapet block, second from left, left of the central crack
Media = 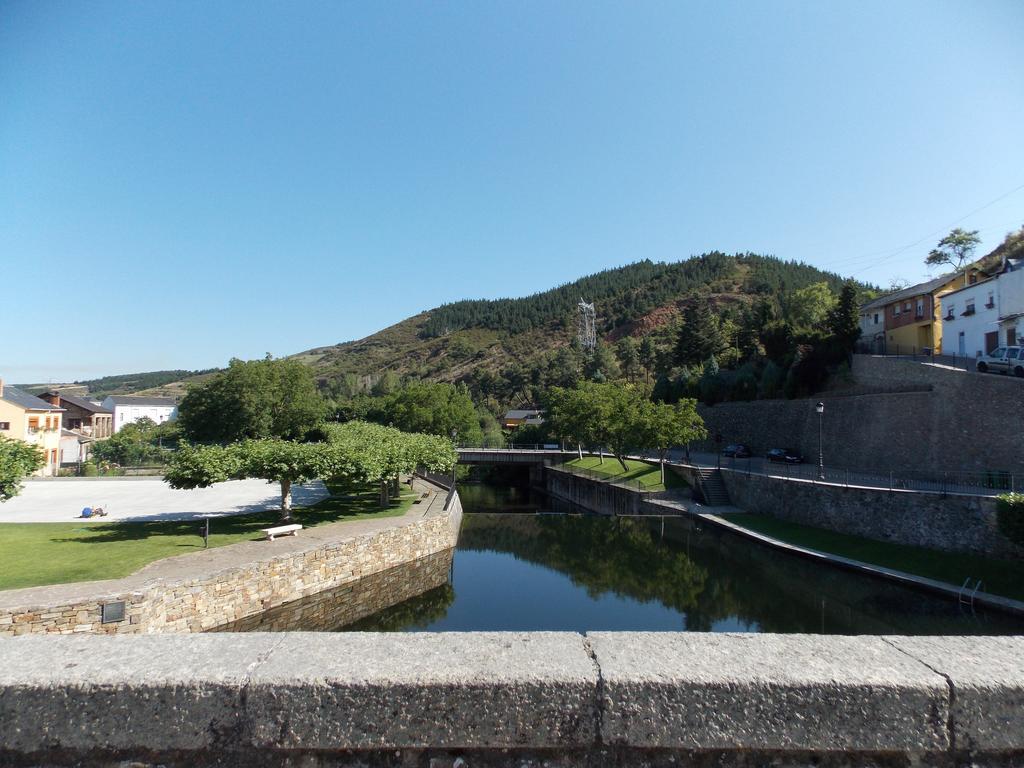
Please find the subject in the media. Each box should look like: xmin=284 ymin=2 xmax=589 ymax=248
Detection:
xmin=247 ymin=632 xmax=597 ymax=750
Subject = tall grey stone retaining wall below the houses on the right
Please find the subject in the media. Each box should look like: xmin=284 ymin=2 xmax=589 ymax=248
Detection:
xmin=698 ymin=354 xmax=1024 ymax=477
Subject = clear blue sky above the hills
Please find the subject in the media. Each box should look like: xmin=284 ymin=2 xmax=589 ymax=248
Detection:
xmin=0 ymin=0 xmax=1024 ymax=382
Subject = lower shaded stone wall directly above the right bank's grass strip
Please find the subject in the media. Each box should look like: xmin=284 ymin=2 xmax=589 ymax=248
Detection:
xmin=722 ymin=468 xmax=1024 ymax=558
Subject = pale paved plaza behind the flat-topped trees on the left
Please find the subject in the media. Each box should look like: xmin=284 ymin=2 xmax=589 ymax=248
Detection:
xmin=0 ymin=477 xmax=330 ymax=522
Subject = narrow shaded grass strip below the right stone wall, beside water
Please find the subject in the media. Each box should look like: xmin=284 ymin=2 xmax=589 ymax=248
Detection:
xmin=722 ymin=513 xmax=1024 ymax=600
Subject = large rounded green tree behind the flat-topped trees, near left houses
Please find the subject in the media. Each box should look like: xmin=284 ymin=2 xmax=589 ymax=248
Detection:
xmin=178 ymin=355 xmax=327 ymax=443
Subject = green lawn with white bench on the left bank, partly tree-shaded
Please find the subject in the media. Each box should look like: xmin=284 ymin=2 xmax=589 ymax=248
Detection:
xmin=0 ymin=484 xmax=416 ymax=590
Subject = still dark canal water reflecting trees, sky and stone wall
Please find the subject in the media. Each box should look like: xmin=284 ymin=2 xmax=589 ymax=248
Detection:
xmin=225 ymin=484 xmax=1024 ymax=635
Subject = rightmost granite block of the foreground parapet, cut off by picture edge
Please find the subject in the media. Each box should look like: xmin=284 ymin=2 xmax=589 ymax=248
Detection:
xmin=886 ymin=637 xmax=1024 ymax=751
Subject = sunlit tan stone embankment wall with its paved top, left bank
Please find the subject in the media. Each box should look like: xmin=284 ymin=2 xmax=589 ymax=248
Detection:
xmin=0 ymin=481 xmax=462 ymax=636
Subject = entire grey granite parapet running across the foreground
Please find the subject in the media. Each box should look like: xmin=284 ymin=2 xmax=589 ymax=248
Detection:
xmin=0 ymin=632 xmax=1024 ymax=763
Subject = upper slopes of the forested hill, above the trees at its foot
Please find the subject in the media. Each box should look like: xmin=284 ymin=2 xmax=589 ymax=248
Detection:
xmin=295 ymin=252 xmax=868 ymax=399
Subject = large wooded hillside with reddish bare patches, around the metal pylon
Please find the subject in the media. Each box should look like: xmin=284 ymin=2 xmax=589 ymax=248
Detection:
xmin=305 ymin=252 xmax=871 ymax=413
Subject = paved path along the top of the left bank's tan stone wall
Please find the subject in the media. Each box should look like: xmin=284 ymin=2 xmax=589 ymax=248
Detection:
xmin=0 ymin=484 xmax=445 ymax=613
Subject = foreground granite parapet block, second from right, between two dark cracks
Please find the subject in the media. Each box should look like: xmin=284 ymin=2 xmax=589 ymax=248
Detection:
xmin=588 ymin=632 xmax=950 ymax=753
